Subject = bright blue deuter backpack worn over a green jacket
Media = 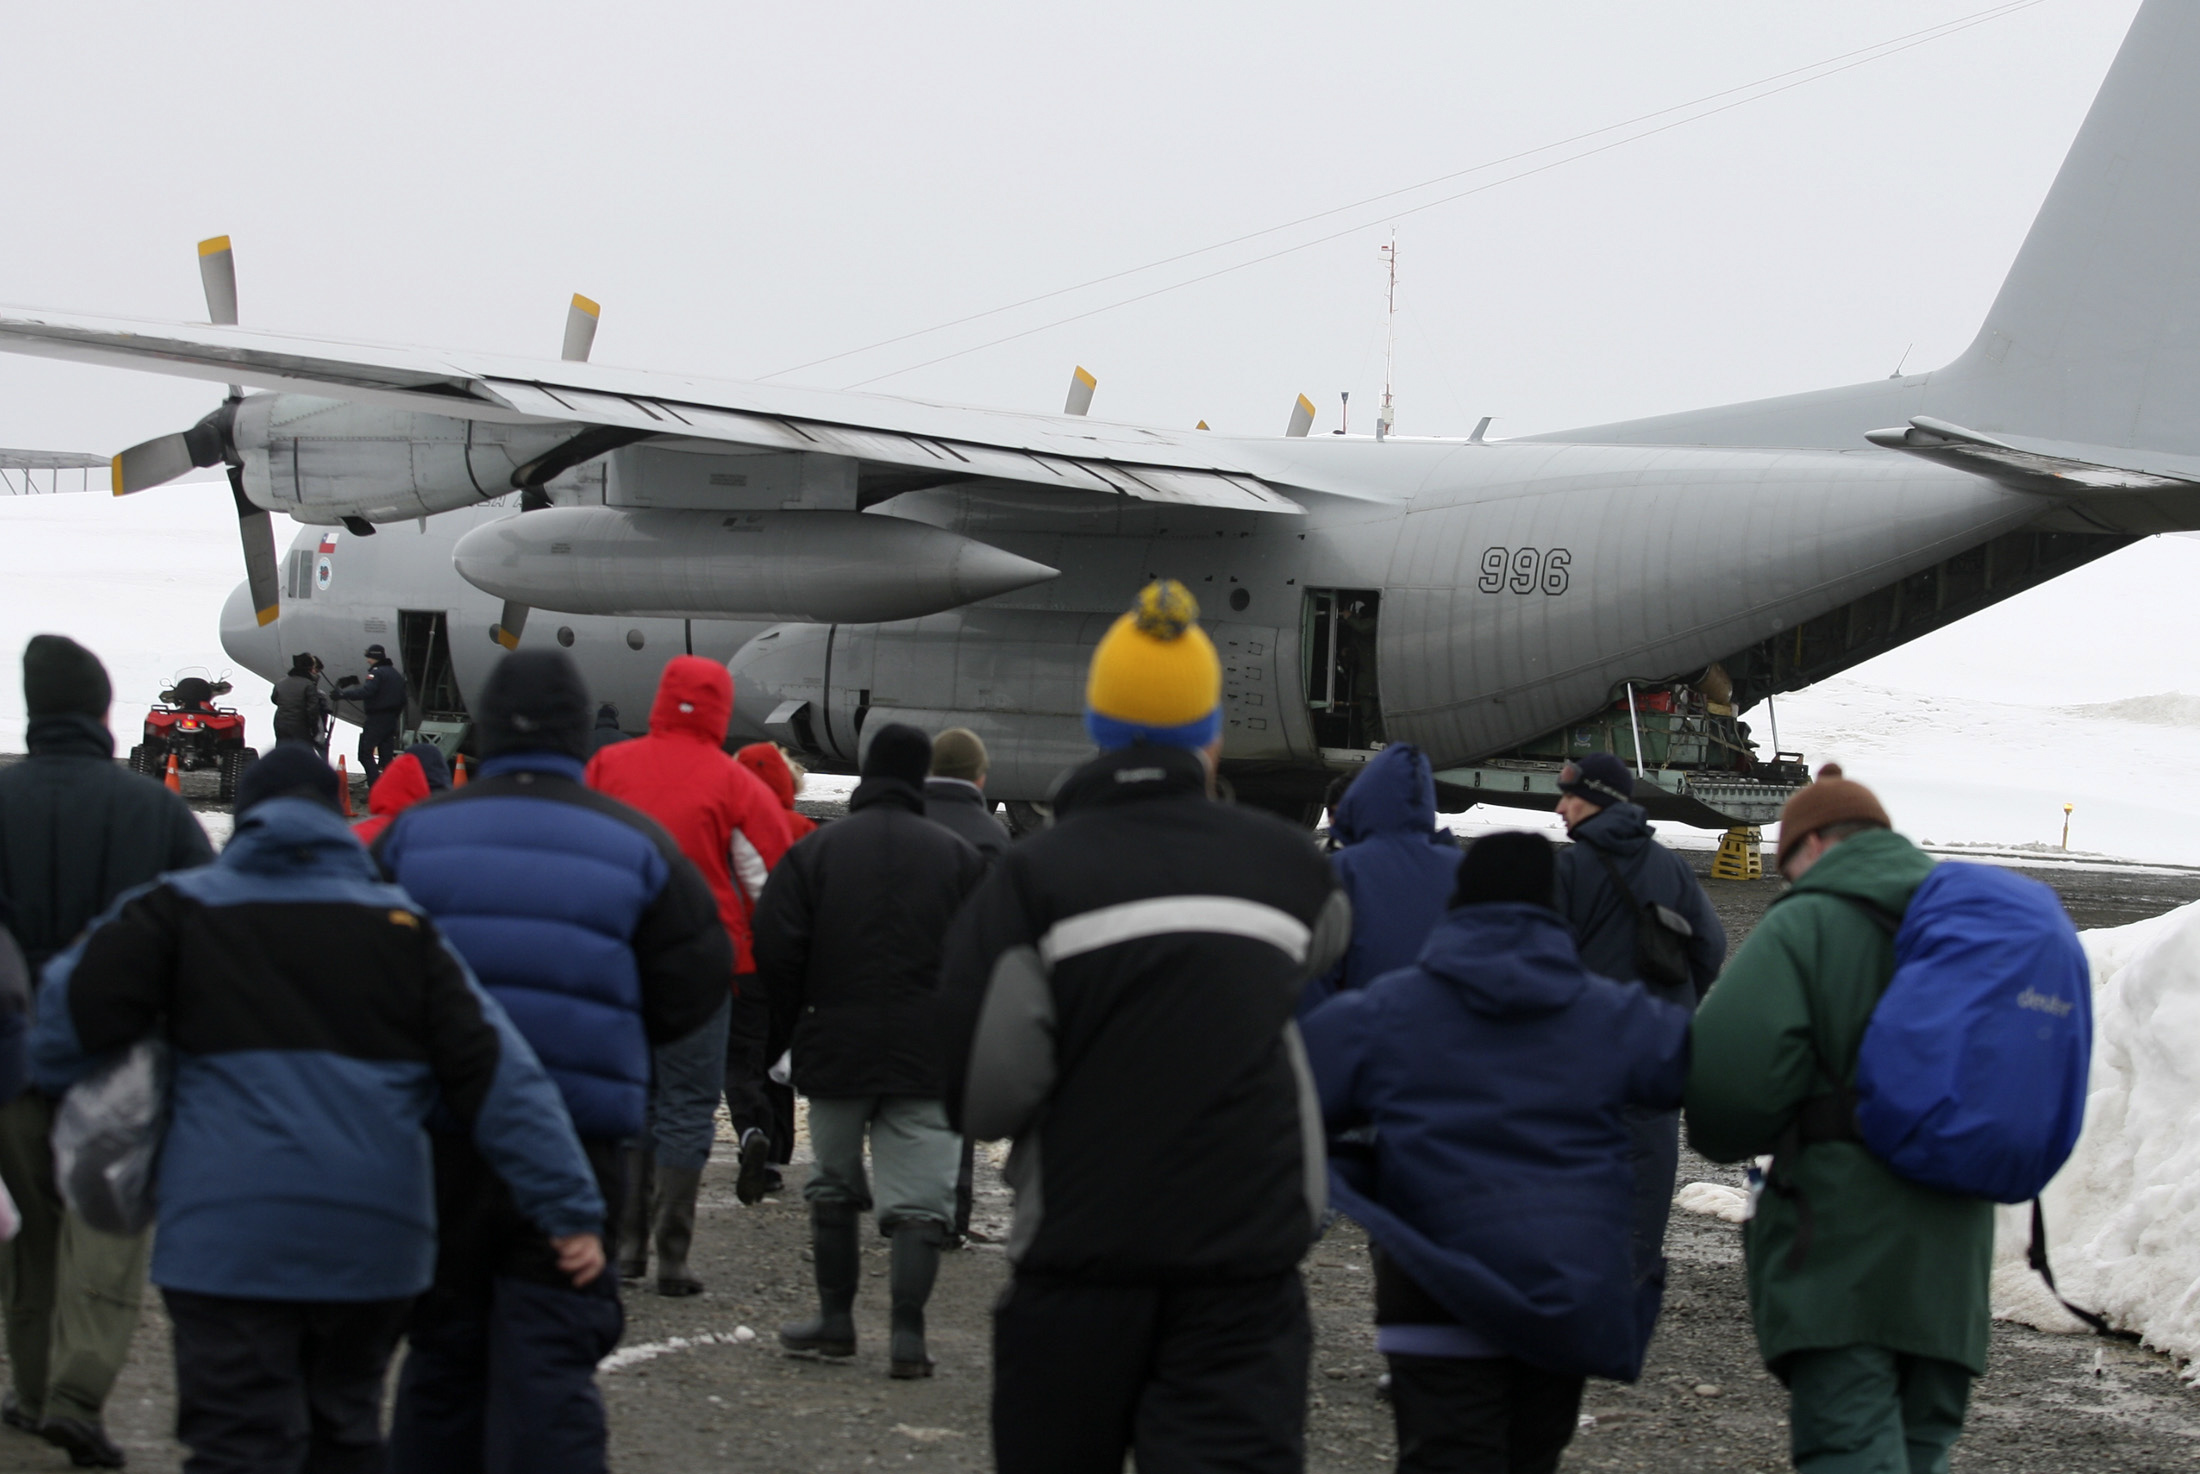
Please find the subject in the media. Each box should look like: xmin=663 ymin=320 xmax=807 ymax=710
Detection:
xmin=1855 ymin=865 xmax=2092 ymax=1203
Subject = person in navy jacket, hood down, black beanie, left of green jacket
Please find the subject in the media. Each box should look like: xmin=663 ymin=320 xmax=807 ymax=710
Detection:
xmin=1302 ymin=834 xmax=1687 ymax=1474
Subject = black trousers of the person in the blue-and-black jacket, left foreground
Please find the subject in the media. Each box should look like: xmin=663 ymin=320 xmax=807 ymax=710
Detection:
xmin=161 ymin=1289 xmax=411 ymax=1474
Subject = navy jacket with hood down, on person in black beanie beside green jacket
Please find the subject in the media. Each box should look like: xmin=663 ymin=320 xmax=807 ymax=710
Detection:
xmin=1305 ymin=902 xmax=1687 ymax=1382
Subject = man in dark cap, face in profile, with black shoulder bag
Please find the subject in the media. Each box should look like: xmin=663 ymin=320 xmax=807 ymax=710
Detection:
xmin=1555 ymin=752 xmax=1727 ymax=1355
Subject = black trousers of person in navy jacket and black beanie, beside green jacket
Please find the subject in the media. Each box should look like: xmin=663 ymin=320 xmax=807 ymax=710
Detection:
xmin=1390 ymin=1355 xmax=1582 ymax=1474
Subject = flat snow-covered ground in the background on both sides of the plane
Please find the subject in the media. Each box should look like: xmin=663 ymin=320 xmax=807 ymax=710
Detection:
xmin=0 ymin=482 xmax=2200 ymax=865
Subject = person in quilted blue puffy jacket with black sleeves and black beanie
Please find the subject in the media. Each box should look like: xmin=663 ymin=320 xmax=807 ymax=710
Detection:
xmin=374 ymin=649 xmax=733 ymax=1474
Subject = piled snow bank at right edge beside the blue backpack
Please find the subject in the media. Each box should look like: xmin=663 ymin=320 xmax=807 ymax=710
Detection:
xmin=1993 ymin=904 xmax=2200 ymax=1382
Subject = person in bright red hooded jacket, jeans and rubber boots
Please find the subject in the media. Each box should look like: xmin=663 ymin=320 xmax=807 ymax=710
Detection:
xmin=587 ymin=656 xmax=788 ymax=1296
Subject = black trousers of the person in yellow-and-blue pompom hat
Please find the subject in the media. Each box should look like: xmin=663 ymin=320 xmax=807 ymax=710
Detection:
xmin=992 ymin=1269 xmax=1313 ymax=1474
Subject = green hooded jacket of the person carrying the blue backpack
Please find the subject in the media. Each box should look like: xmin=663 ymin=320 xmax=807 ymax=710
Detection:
xmin=1687 ymin=829 xmax=1993 ymax=1373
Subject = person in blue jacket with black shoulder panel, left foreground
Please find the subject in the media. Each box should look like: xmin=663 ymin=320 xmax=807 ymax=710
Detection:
xmin=31 ymin=741 xmax=609 ymax=1470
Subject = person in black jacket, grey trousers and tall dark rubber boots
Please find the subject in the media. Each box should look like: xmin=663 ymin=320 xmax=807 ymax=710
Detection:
xmin=755 ymin=724 xmax=983 ymax=1377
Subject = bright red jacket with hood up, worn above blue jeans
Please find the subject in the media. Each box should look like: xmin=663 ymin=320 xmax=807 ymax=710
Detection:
xmin=587 ymin=656 xmax=788 ymax=975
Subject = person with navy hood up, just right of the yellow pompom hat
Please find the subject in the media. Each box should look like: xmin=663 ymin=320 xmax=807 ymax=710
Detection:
xmin=1298 ymin=741 xmax=1459 ymax=1019
